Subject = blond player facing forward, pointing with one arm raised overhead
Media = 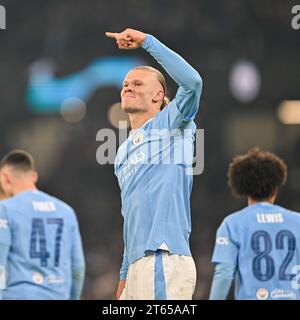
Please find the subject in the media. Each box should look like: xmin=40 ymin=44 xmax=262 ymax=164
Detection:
xmin=106 ymin=29 xmax=202 ymax=299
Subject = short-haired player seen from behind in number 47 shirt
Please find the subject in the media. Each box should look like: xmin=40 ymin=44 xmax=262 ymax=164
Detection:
xmin=0 ymin=150 xmax=85 ymax=300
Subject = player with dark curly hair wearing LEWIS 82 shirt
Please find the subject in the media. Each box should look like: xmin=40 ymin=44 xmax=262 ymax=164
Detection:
xmin=210 ymin=148 xmax=300 ymax=300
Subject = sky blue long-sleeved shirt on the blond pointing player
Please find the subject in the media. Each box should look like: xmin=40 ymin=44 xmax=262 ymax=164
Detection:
xmin=115 ymin=35 xmax=202 ymax=279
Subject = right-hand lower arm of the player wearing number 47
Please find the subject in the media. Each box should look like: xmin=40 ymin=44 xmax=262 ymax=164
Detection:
xmin=70 ymin=215 xmax=85 ymax=300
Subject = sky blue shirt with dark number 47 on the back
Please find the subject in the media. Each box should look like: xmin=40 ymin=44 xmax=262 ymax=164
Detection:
xmin=0 ymin=190 xmax=84 ymax=300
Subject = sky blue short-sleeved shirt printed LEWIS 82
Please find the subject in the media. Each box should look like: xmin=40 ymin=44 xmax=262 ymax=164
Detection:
xmin=212 ymin=202 xmax=300 ymax=300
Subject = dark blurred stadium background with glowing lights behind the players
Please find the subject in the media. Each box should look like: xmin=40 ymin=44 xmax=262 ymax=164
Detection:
xmin=0 ymin=0 xmax=300 ymax=299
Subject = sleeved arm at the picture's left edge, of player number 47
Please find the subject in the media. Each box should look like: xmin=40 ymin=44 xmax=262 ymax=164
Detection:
xmin=0 ymin=205 xmax=11 ymax=300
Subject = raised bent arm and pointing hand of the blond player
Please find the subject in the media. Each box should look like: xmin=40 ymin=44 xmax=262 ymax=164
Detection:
xmin=106 ymin=29 xmax=202 ymax=120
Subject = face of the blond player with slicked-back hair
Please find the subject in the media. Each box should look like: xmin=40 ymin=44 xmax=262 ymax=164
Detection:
xmin=121 ymin=69 xmax=164 ymax=113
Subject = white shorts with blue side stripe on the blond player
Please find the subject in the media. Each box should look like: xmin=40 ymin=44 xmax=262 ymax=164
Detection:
xmin=120 ymin=249 xmax=197 ymax=300
